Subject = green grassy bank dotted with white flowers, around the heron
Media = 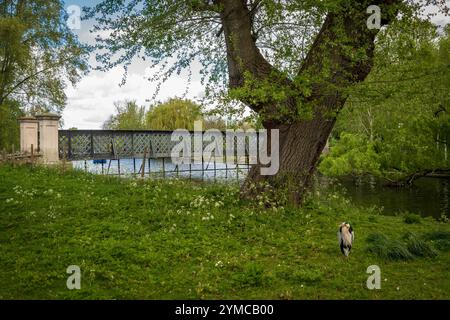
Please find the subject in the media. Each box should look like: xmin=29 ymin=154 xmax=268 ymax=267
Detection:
xmin=0 ymin=166 xmax=450 ymax=299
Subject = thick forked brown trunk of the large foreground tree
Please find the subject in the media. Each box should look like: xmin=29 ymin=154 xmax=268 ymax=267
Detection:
xmin=216 ymin=0 xmax=400 ymax=205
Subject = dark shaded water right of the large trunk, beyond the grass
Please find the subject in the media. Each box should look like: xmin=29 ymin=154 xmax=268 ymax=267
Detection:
xmin=321 ymin=178 xmax=450 ymax=218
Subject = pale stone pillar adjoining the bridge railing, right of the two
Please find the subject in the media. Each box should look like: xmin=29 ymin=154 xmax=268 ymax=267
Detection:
xmin=36 ymin=113 xmax=61 ymax=164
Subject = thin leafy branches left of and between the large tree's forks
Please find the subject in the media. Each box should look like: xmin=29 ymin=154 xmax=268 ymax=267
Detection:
xmin=85 ymin=0 xmax=330 ymax=102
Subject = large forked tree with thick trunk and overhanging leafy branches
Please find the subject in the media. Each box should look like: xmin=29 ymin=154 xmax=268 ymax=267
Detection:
xmin=85 ymin=0 xmax=445 ymax=204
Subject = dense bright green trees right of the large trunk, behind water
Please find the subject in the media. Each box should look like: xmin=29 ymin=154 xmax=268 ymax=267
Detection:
xmin=320 ymin=22 xmax=450 ymax=184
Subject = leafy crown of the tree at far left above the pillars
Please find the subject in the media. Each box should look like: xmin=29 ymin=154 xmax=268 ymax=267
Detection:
xmin=0 ymin=0 xmax=88 ymax=112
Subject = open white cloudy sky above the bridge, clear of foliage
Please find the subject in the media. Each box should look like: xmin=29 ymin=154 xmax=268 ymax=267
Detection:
xmin=62 ymin=0 xmax=450 ymax=129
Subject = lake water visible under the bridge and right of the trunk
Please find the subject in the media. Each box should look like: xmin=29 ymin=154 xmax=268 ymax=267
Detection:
xmin=73 ymin=159 xmax=450 ymax=218
